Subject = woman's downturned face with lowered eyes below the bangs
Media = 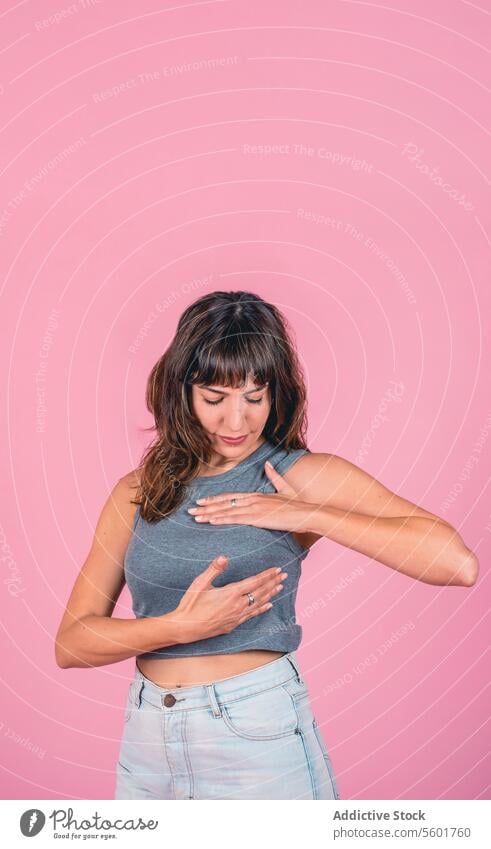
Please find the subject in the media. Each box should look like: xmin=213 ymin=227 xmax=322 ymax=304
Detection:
xmin=191 ymin=378 xmax=271 ymax=459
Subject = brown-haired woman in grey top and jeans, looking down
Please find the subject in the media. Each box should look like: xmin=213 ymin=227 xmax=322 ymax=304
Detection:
xmin=56 ymin=292 xmax=478 ymax=799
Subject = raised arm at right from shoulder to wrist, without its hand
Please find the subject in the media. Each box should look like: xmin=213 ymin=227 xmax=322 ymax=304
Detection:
xmin=284 ymin=454 xmax=479 ymax=587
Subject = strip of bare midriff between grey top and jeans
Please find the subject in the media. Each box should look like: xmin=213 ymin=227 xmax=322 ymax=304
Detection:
xmin=136 ymin=649 xmax=285 ymax=689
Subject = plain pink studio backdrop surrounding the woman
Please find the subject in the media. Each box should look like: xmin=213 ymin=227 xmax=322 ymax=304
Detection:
xmin=0 ymin=0 xmax=491 ymax=799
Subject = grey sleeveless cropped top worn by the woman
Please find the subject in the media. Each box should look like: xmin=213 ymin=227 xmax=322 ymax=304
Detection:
xmin=124 ymin=441 xmax=309 ymax=659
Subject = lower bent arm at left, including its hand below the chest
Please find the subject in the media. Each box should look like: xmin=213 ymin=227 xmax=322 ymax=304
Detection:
xmin=55 ymin=472 xmax=282 ymax=669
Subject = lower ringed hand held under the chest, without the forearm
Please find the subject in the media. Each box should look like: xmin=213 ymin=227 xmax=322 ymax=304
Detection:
xmin=174 ymin=555 xmax=288 ymax=643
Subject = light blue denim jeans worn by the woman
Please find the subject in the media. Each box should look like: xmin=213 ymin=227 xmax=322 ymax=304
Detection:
xmin=114 ymin=652 xmax=340 ymax=799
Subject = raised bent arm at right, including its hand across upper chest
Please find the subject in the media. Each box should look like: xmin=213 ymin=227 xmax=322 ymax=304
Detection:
xmin=189 ymin=453 xmax=479 ymax=587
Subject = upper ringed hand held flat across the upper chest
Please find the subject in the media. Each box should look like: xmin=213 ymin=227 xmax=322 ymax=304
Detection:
xmin=188 ymin=463 xmax=314 ymax=532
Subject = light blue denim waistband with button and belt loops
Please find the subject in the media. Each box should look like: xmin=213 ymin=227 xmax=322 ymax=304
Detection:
xmin=130 ymin=652 xmax=304 ymax=716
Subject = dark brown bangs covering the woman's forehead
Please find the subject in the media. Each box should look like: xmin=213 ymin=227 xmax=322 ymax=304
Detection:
xmin=186 ymin=332 xmax=279 ymax=389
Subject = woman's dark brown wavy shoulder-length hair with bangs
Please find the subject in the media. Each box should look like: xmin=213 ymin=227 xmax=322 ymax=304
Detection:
xmin=132 ymin=292 xmax=307 ymax=522
